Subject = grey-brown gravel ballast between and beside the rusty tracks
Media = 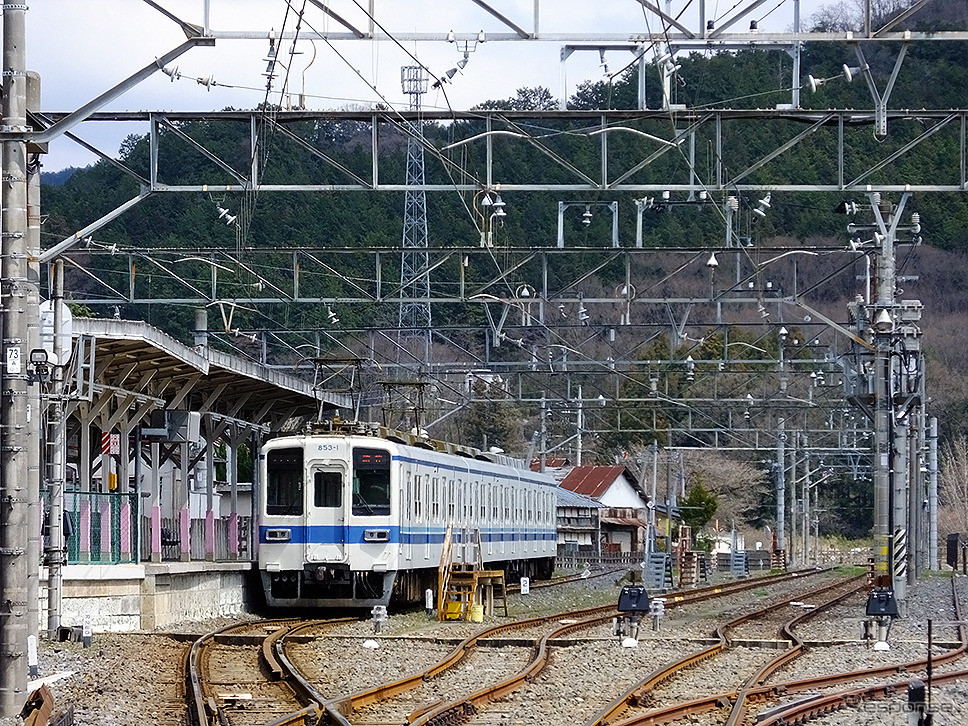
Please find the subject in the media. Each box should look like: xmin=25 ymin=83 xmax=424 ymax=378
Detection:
xmin=0 ymin=575 xmax=968 ymax=726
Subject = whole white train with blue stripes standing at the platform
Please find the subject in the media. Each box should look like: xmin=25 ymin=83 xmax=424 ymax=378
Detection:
xmin=257 ymin=425 xmax=557 ymax=608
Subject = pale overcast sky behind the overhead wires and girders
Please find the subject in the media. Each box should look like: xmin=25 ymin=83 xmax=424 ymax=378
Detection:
xmin=26 ymin=0 xmax=828 ymax=171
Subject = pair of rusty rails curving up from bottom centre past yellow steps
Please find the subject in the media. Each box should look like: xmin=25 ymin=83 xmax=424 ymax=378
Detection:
xmin=326 ymin=569 xmax=826 ymax=726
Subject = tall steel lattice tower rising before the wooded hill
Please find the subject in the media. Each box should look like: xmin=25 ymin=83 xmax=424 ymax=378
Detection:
xmin=397 ymin=66 xmax=430 ymax=368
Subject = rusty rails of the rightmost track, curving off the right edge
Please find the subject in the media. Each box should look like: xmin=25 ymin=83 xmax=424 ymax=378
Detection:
xmin=600 ymin=578 xmax=968 ymax=726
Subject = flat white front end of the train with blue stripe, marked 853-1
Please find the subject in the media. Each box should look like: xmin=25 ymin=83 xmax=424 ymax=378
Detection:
xmin=259 ymin=436 xmax=400 ymax=608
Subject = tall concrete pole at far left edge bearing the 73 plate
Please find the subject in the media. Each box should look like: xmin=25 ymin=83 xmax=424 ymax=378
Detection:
xmin=0 ymin=4 xmax=29 ymax=717
